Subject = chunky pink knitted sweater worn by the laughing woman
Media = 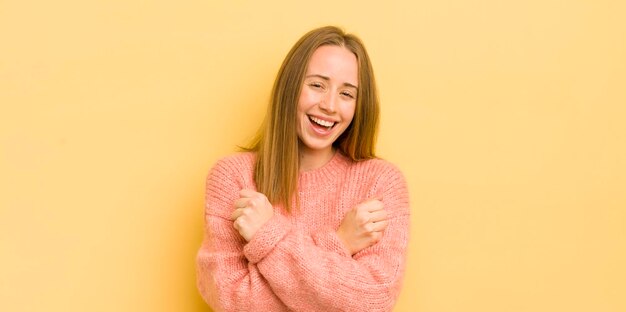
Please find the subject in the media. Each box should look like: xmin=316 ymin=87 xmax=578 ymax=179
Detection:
xmin=197 ymin=152 xmax=409 ymax=311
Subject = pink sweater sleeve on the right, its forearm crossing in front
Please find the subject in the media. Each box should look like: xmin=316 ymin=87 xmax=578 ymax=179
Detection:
xmin=244 ymin=167 xmax=409 ymax=311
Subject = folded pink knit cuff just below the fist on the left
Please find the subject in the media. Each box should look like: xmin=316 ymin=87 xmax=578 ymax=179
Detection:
xmin=243 ymin=213 xmax=291 ymax=264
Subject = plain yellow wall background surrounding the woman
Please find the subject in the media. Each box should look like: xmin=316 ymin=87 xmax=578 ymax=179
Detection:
xmin=0 ymin=0 xmax=626 ymax=312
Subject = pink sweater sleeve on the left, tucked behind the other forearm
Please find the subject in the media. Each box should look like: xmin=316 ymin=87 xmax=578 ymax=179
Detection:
xmin=196 ymin=160 xmax=288 ymax=311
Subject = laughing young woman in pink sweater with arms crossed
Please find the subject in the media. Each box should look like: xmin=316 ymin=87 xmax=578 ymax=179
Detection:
xmin=197 ymin=27 xmax=409 ymax=311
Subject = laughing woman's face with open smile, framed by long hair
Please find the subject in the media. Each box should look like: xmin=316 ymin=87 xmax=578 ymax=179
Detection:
xmin=297 ymin=45 xmax=358 ymax=155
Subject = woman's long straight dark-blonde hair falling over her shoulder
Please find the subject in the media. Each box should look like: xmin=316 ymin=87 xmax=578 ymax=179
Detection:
xmin=244 ymin=26 xmax=379 ymax=211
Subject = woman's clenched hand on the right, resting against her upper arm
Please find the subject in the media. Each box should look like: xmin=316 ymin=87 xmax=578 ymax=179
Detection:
xmin=337 ymin=199 xmax=389 ymax=255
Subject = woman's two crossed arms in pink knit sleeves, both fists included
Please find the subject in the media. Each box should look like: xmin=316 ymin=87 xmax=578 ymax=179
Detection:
xmin=198 ymin=162 xmax=408 ymax=311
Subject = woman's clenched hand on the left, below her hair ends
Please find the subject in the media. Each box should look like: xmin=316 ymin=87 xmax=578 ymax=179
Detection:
xmin=230 ymin=189 xmax=274 ymax=242
